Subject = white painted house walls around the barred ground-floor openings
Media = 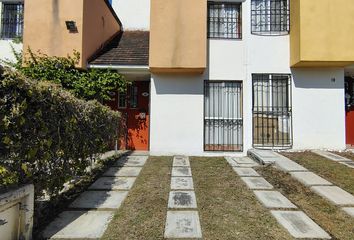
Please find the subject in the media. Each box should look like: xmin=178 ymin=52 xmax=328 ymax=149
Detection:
xmin=108 ymin=0 xmax=345 ymax=156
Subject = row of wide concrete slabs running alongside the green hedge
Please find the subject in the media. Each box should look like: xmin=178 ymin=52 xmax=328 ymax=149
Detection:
xmin=42 ymin=153 xmax=148 ymax=239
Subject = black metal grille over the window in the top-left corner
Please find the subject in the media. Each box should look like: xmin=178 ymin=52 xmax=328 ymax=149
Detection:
xmin=0 ymin=3 xmax=23 ymax=39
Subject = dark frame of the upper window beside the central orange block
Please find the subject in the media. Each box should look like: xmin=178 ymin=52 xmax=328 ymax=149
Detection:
xmin=207 ymin=1 xmax=243 ymax=40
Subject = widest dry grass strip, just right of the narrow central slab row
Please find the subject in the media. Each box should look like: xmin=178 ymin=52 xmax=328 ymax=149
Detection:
xmin=191 ymin=158 xmax=291 ymax=240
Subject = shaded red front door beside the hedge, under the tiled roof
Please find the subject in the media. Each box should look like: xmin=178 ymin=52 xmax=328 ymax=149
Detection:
xmin=108 ymin=81 xmax=150 ymax=151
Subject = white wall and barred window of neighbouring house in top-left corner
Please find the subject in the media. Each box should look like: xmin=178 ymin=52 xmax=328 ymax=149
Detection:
xmin=0 ymin=0 xmax=24 ymax=65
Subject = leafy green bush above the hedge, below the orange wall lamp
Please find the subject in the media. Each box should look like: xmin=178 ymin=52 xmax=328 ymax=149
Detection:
xmin=5 ymin=48 xmax=129 ymax=102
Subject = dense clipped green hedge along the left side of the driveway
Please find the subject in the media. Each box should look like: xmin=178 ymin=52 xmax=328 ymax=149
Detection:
xmin=0 ymin=71 xmax=120 ymax=196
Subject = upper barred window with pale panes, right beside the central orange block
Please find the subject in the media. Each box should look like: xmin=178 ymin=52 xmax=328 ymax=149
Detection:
xmin=208 ymin=2 xmax=242 ymax=39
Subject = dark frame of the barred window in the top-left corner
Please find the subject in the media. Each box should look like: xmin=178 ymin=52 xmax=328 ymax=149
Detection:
xmin=0 ymin=1 xmax=24 ymax=40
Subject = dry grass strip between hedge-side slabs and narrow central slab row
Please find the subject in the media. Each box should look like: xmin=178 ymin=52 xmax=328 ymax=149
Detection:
xmin=103 ymin=157 xmax=172 ymax=240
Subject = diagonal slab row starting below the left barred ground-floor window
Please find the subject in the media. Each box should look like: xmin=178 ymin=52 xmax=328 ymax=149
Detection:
xmin=225 ymin=157 xmax=331 ymax=239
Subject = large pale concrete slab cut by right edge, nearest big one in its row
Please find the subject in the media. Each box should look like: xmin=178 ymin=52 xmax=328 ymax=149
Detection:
xmin=311 ymin=186 xmax=354 ymax=205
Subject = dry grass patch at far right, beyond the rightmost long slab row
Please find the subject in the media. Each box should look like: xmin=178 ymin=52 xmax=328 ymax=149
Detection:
xmin=282 ymin=152 xmax=354 ymax=194
